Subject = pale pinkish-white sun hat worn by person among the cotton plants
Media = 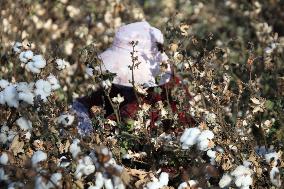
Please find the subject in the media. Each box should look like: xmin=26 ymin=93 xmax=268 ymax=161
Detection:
xmin=99 ymin=22 xmax=171 ymax=87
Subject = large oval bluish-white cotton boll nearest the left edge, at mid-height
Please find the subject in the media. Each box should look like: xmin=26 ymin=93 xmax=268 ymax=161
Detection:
xmin=4 ymin=85 xmax=19 ymax=108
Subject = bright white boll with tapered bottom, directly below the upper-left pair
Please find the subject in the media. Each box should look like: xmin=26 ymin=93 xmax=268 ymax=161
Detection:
xmin=34 ymin=79 xmax=51 ymax=102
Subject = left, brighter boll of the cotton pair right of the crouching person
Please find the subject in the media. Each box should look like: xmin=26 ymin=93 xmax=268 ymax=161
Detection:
xmin=180 ymin=127 xmax=201 ymax=149
